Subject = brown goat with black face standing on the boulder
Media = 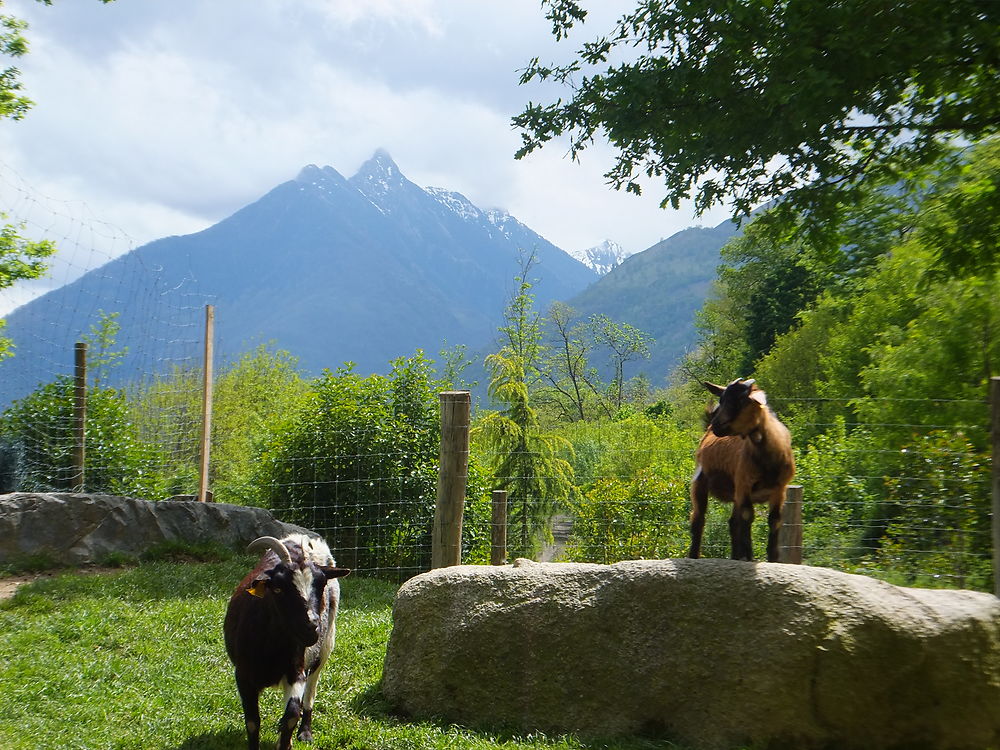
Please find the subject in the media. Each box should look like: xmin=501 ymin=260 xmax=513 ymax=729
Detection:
xmin=688 ymin=379 xmax=795 ymax=562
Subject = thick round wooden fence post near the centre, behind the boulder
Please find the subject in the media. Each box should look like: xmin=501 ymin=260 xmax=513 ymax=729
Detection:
xmin=431 ymin=391 xmax=472 ymax=568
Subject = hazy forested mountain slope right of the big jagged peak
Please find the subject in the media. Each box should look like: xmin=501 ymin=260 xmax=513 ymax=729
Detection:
xmin=567 ymin=220 xmax=739 ymax=386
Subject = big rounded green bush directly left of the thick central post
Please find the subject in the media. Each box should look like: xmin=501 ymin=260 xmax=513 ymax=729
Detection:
xmin=254 ymin=352 xmax=482 ymax=575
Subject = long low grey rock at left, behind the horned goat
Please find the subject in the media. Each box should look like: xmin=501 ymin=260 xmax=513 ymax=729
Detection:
xmin=0 ymin=492 xmax=312 ymax=565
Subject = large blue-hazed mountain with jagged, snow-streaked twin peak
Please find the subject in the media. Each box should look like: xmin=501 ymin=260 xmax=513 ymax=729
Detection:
xmin=0 ymin=150 xmax=597 ymax=406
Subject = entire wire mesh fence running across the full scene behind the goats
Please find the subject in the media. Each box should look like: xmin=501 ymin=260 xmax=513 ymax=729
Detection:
xmin=0 ymin=164 xmax=993 ymax=590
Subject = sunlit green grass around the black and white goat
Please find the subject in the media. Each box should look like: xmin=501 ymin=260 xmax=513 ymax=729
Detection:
xmin=0 ymin=551 xmax=688 ymax=750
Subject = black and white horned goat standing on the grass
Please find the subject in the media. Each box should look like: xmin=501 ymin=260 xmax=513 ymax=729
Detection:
xmin=223 ymin=534 xmax=350 ymax=750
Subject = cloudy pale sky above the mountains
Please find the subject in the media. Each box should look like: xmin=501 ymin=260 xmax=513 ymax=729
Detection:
xmin=0 ymin=0 xmax=726 ymax=315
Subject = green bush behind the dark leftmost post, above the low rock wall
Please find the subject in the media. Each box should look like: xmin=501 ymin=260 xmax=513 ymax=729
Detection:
xmin=0 ymin=376 xmax=163 ymax=500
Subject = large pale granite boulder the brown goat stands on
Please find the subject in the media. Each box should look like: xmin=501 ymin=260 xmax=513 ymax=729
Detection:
xmin=383 ymin=560 xmax=1000 ymax=750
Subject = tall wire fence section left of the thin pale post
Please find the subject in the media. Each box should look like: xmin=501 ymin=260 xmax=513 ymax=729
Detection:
xmin=0 ymin=162 xmax=206 ymax=498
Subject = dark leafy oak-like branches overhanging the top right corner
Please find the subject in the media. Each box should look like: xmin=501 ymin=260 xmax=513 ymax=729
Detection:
xmin=513 ymin=0 xmax=1000 ymax=261
